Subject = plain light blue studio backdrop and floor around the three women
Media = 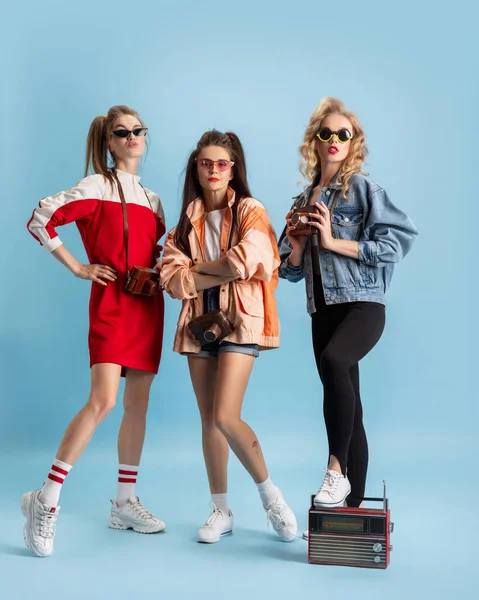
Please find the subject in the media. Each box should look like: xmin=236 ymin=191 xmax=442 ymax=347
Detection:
xmin=0 ymin=0 xmax=479 ymax=600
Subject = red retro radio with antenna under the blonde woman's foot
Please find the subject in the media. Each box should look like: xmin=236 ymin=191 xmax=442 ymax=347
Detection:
xmin=308 ymin=482 xmax=394 ymax=569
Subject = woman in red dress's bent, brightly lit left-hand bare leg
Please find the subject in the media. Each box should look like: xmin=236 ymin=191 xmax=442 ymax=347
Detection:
xmin=56 ymin=363 xmax=121 ymax=465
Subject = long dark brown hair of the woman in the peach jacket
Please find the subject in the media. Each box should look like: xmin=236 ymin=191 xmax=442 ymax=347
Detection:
xmin=175 ymin=129 xmax=251 ymax=257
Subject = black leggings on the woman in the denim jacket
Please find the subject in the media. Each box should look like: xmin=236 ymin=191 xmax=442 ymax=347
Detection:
xmin=312 ymin=277 xmax=386 ymax=506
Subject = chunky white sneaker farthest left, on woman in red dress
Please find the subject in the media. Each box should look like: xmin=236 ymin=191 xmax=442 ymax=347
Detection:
xmin=22 ymin=489 xmax=60 ymax=558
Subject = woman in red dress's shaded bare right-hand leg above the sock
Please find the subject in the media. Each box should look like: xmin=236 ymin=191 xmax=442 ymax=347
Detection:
xmin=118 ymin=369 xmax=155 ymax=466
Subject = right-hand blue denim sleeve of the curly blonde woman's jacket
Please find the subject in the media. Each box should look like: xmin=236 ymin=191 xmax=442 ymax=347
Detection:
xmin=359 ymin=188 xmax=417 ymax=267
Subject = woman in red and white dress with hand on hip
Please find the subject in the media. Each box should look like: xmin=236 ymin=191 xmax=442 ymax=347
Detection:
xmin=22 ymin=106 xmax=166 ymax=557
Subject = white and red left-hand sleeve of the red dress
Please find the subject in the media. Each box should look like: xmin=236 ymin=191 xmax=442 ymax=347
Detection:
xmin=27 ymin=175 xmax=105 ymax=252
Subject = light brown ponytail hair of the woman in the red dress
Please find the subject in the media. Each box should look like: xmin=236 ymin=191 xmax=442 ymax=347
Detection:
xmin=85 ymin=104 xmax=145 ymax=185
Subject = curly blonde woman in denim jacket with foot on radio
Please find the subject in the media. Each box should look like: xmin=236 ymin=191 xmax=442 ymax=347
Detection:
xmin=279 ymin=98 xmax=417 ymax=520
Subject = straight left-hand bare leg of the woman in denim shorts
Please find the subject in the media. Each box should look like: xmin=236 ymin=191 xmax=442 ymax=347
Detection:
xmin=188 ymin=356 xmax=229 ymax=494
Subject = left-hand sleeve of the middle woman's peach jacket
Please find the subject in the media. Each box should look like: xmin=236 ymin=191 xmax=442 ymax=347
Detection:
xmin=160 ymin=229 xmax=198 ymax=300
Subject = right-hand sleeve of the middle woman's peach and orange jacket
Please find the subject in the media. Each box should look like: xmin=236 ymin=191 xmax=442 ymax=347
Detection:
xmin=226 ymin=200 xmax=279 ymax=281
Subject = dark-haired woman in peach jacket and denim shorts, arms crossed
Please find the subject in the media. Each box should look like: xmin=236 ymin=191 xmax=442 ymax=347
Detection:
xmin=161 ymin=130 xmax=297 ymax=543
